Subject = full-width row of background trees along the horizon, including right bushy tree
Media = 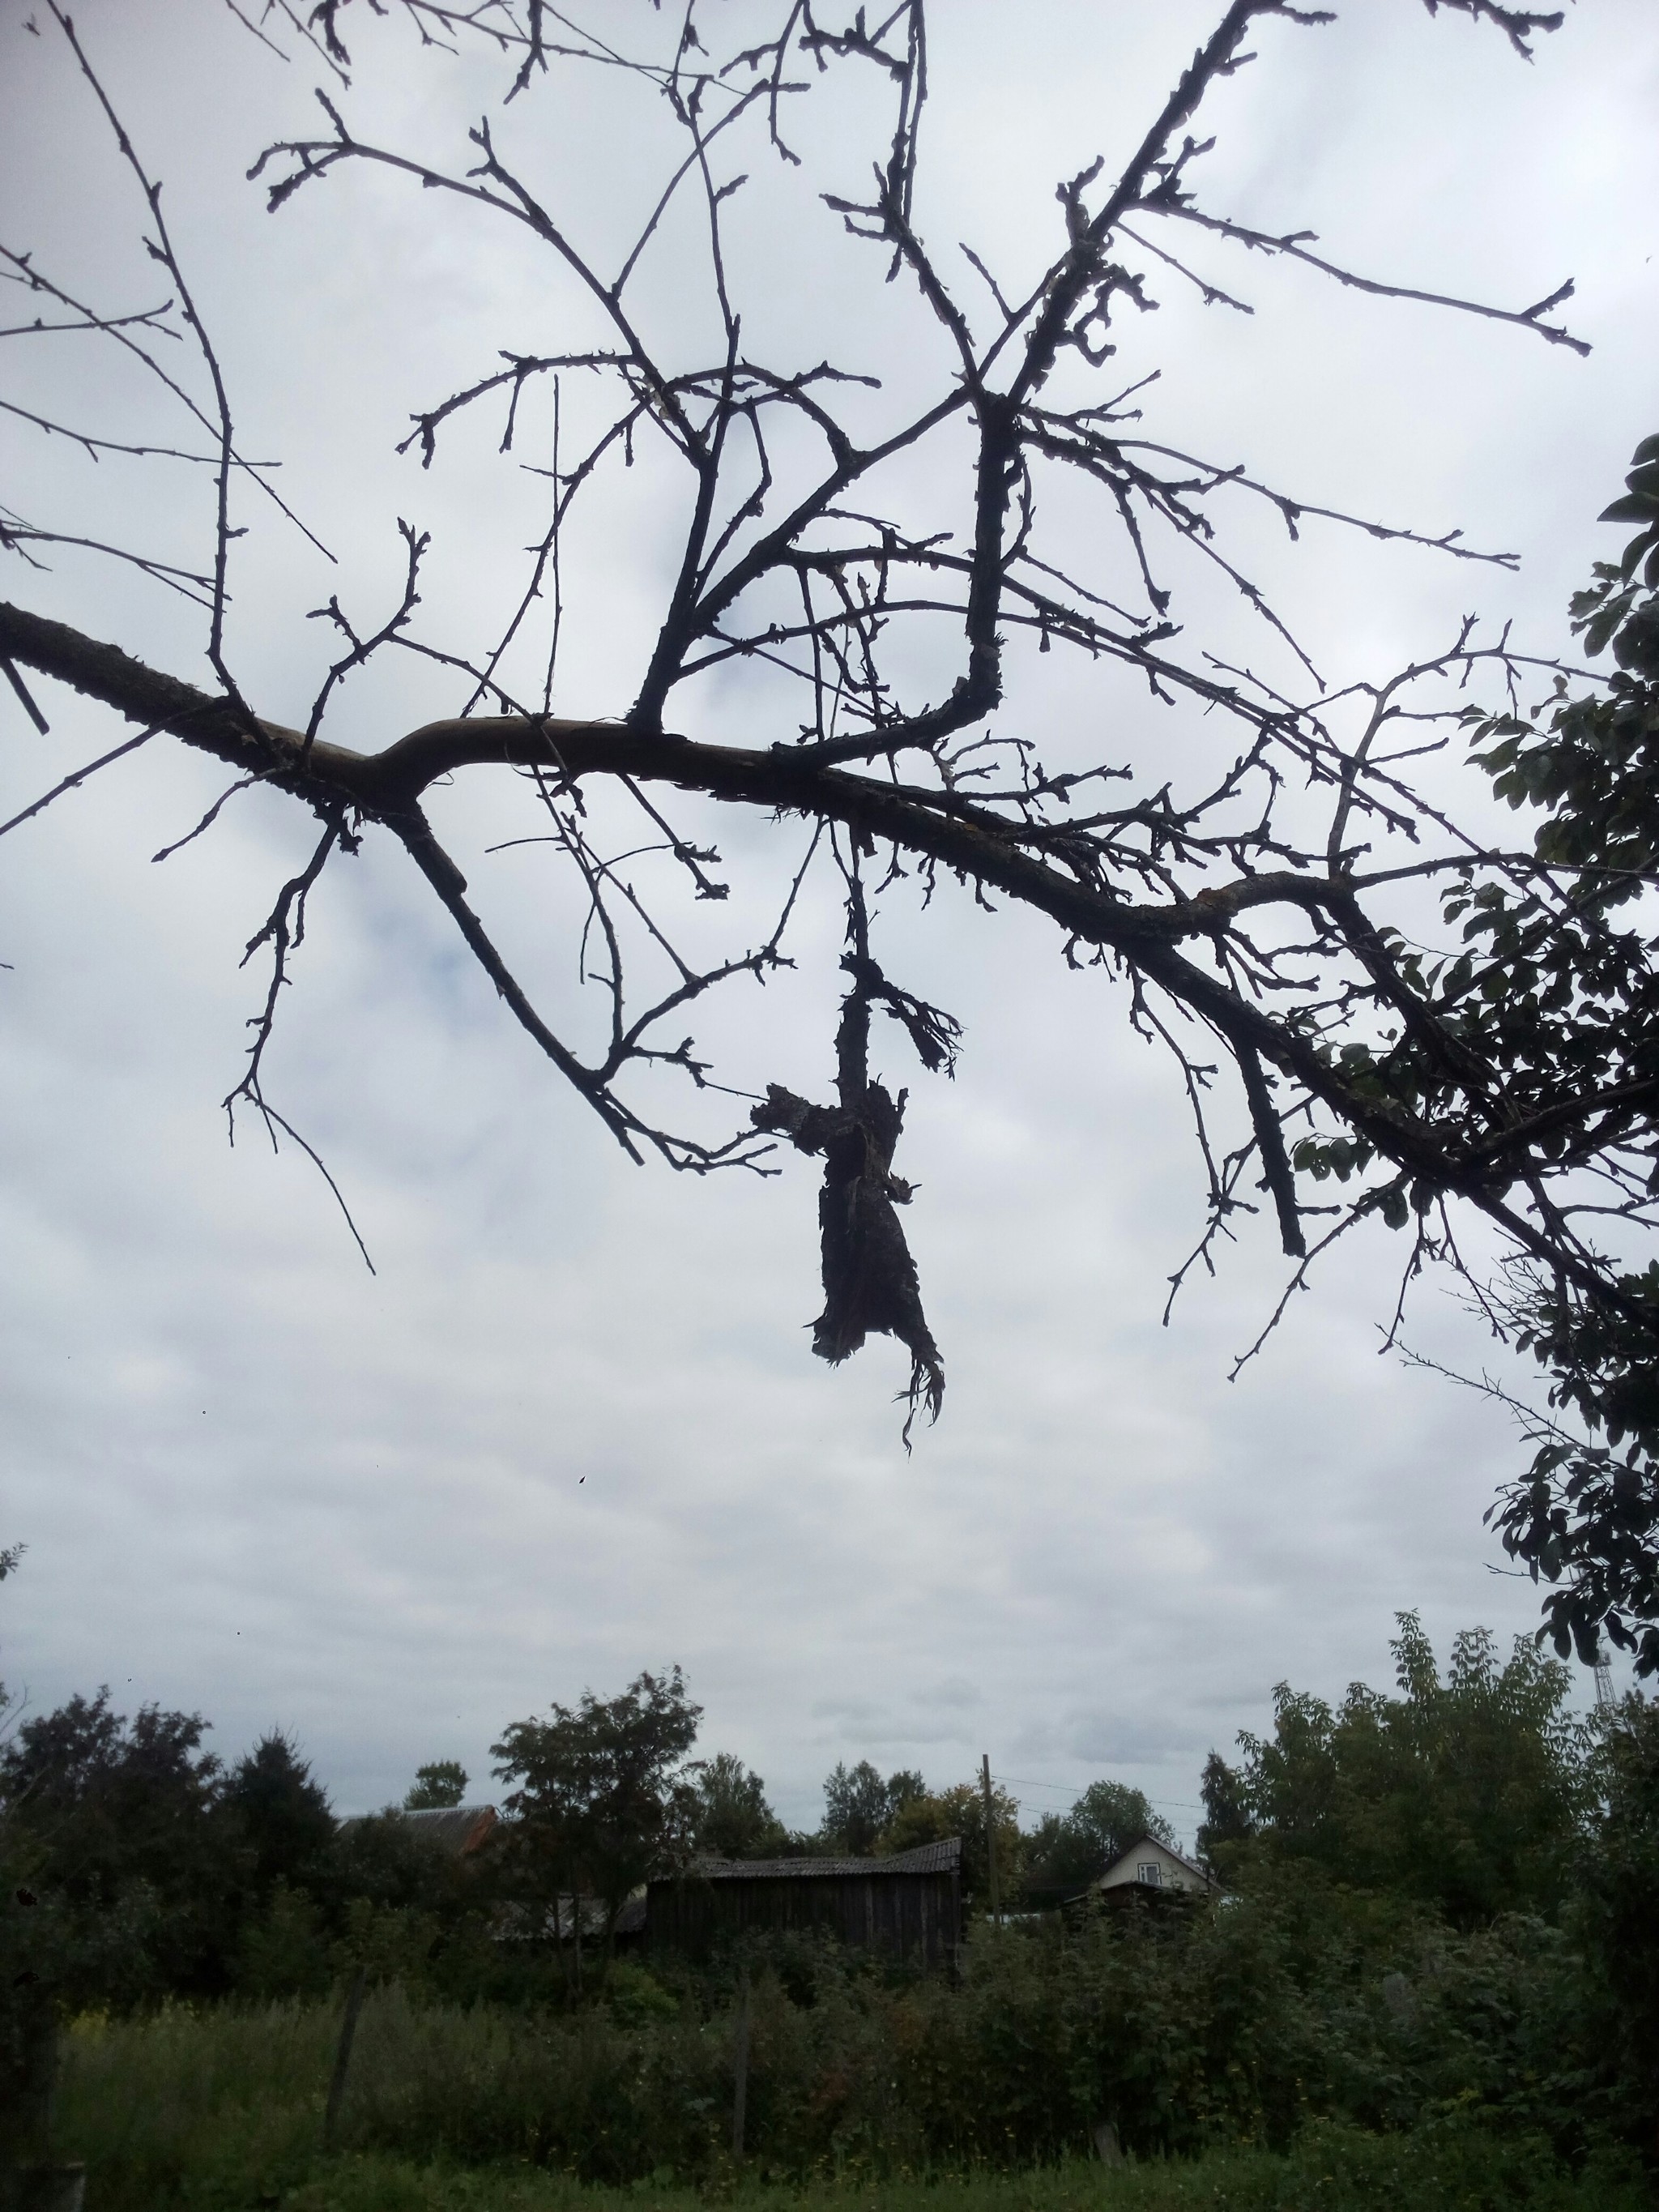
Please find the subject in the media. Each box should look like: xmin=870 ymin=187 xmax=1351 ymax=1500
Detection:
xmin=0 ymin=1615 xmax=1650 ymax=2009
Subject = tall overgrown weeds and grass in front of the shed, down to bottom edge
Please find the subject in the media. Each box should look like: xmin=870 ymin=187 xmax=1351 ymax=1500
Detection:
xmin=55 ymin=1909 xmax=1648 ymax=2212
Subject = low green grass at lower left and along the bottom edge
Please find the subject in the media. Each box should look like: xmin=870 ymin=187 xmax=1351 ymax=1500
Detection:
xmin=53 ymin=1988 xmax=1653 ymax=2212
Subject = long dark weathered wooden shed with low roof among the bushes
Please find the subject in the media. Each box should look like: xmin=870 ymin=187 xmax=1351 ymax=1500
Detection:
xmin=646 ymin=1836 xmax=962 ymax=1966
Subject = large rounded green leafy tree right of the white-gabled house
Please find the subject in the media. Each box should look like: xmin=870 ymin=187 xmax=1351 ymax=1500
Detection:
xmin=1230 ymin=1612 xmax=1590 ymax=1927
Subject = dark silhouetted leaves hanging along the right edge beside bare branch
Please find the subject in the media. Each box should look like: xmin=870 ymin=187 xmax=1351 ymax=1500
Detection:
xmin=1440 ymin=436 xmax=1659 ymax=1675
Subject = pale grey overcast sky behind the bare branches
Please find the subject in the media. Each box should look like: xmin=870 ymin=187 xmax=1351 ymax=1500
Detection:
xmin=0 ymin=0 xmax=1659 ymax=1836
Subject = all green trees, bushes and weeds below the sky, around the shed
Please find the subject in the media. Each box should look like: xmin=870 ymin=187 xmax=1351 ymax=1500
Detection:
xmin=0 ymin=1615 xmax=1659 ymax=2212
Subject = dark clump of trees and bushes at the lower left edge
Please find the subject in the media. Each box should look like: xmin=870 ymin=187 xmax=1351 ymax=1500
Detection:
xmin=0 ymin=1692 xmax=506 ymax=2026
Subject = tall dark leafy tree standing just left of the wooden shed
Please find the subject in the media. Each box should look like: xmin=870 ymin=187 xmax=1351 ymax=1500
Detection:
xmin=491 ymin=1668 xmax=703 ymax=1954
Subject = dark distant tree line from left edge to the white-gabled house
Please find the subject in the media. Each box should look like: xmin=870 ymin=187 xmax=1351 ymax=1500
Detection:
xmin=0 ymin=1668 xmax=1172 ymax=2011
